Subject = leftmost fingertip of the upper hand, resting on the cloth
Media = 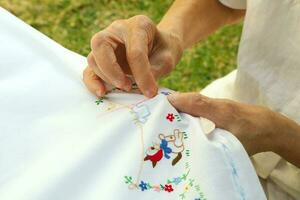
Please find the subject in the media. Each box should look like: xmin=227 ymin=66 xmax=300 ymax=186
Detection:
xmin=83 ymin=66 xmax=105 ymax=97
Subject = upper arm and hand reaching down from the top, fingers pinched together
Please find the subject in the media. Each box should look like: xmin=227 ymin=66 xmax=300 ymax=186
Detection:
xmin=83 ymin=0 xmax=244 ymax=97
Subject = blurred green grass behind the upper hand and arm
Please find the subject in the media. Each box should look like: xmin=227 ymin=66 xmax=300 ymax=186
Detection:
xmin=0 ymin=0 xmax=242 ymax=91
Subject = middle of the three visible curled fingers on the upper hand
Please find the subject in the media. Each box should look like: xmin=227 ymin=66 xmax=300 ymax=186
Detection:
xmin=91 ymin=31 xmax=131 ymax=91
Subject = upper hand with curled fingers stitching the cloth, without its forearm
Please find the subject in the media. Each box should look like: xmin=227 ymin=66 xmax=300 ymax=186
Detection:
xmin=83 ymin=15 xmax=183 ymax=97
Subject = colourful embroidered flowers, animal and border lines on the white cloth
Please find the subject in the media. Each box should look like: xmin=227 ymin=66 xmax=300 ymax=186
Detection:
xmin=95 ymin=94 xmax=206 ymax=200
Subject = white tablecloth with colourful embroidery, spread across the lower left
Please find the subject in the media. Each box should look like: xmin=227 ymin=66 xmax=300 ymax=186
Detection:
xmin=0 ymin=9 xmax=266 ymax=200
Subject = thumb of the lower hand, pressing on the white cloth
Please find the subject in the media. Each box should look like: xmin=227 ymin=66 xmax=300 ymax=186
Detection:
xmin=168 ymin=92 xmax=219 ymax=123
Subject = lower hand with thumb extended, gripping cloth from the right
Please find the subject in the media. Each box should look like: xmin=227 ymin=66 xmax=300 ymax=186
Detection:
xmin=168 ymin=93 xmax=300 ymax=158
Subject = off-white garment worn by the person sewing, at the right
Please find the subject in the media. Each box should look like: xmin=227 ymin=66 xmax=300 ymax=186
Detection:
xmin=203 ymin=0 xmax=300 ymax=199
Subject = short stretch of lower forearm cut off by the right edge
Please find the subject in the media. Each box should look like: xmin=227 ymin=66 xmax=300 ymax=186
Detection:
xmin=273 ymin=114 xmax=300 ymax=167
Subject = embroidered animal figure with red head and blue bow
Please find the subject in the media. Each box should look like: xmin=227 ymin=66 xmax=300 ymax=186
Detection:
xmin=144 ymin=129 xmax=184 ymax=168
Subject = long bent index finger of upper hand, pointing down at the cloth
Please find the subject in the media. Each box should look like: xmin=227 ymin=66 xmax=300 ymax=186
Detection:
xmin=125 ymin=23 xmax=158 ymax=97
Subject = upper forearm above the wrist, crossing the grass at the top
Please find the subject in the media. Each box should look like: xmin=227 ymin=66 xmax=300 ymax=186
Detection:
xmin=158 ymin=0 xmax=245 ymax=49
